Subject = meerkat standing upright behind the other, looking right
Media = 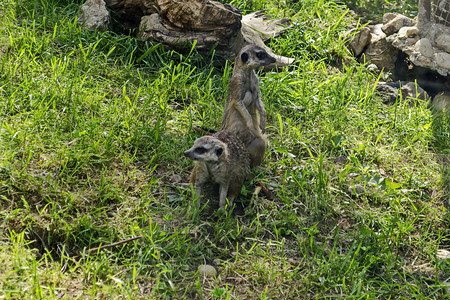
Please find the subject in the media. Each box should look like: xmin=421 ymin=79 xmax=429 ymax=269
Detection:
xmin=222 ymin=45 xmax=276 ymax=167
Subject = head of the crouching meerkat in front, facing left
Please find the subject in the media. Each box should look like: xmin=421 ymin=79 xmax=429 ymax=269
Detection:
xmin=184 ymin=136 xmax=228 ymax=162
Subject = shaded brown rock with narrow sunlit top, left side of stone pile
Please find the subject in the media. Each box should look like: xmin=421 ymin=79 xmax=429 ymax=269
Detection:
xmin=360 ymin=24 xmax=398 ymax=71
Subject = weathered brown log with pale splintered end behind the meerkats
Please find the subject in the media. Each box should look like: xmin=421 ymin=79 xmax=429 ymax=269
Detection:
xmin=138 ymin=0 xmax=294 ymax=64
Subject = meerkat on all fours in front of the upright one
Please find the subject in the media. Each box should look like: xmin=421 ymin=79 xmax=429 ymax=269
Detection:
xmin=184 ymin=131 xmax=250 ymax=209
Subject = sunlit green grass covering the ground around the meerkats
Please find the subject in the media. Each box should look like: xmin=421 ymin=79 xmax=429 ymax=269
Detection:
xmin=0 ymin=0 xmax=450 ymax=299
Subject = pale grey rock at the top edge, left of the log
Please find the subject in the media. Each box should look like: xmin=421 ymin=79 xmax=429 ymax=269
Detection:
xmin=78 ymin=0 xmax=109 ymax=31
